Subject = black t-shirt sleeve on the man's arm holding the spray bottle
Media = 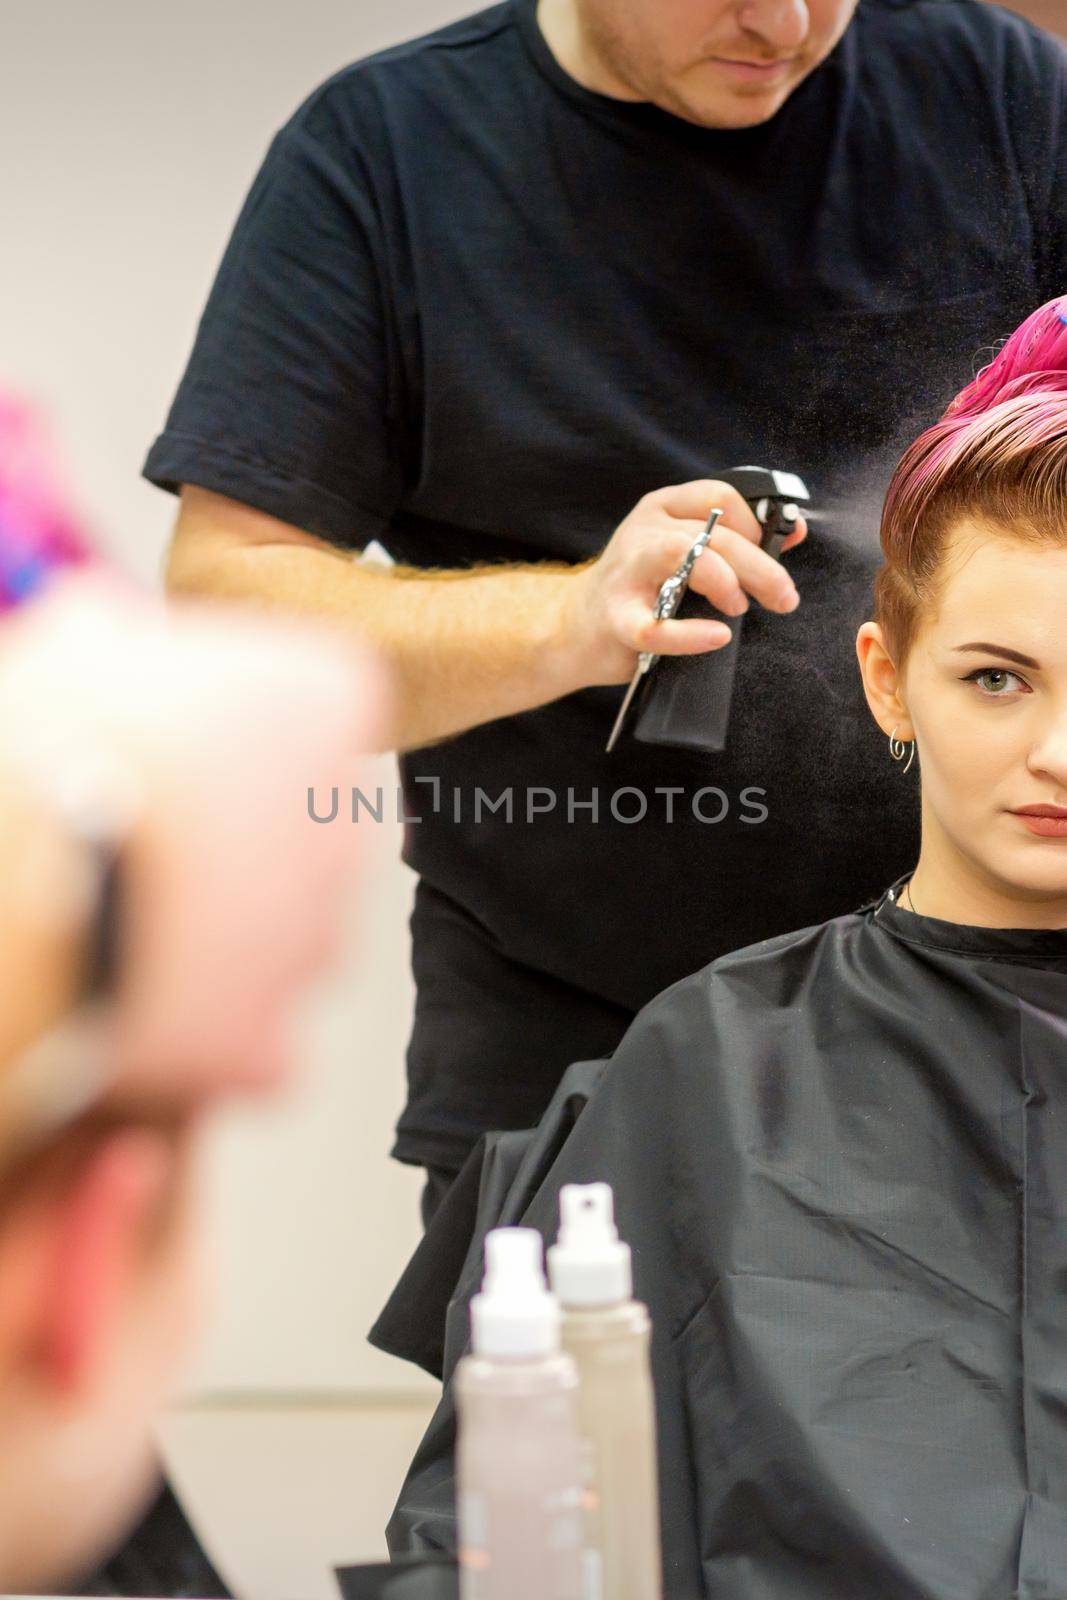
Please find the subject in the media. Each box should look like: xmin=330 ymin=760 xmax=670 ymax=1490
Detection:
xmin=144 ymin=123 xmax=402 ymax=546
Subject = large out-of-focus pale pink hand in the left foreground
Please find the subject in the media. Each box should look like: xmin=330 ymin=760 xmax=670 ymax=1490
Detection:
xmin=0 ymin=578 xmax=382 ymax=1104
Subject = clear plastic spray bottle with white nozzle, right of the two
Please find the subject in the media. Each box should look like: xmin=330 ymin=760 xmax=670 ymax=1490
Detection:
xmin=549 ymin=1184 xmax=662 ymax=1600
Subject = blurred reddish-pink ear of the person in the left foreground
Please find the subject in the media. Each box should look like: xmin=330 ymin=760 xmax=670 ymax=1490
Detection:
xmin=32 ymin=1128 xmax=174 ymax=1394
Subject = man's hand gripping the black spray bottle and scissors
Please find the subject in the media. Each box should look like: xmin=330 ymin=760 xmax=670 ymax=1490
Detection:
xmin=569 ymin=478 xmax=808 ymax=685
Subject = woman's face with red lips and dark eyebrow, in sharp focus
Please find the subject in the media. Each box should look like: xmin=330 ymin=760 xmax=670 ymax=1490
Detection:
xmin=897 ymin=522 xmax=1067 ymax=906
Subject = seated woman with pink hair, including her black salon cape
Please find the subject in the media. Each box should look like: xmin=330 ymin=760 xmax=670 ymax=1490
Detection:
xmin=392 ymin=298 xmax=1067 ymax=1600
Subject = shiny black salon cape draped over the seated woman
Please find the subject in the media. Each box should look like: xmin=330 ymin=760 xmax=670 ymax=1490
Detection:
xmin=390 ymin=886 xmax=1067 ymax=1600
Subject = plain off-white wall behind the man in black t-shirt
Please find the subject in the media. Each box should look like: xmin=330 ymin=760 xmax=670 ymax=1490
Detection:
xmin=0 ymin=0 xmax=472 ymax=1392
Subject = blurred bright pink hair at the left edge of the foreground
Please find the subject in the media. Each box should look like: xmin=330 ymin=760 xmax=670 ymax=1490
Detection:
xmin=0 ymin=390 xmax=98 ymax=613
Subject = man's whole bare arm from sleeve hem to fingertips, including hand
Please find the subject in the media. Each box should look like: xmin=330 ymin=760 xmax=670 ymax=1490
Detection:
xmin=166 ymin=478 xmax=806 ymax=749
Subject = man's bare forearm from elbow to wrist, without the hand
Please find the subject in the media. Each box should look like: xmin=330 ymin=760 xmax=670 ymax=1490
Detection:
xmin=168 ymin=541 xmax=595 ymax=749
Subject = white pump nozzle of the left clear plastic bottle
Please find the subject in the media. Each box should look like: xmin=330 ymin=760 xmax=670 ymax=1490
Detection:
xmin=470 ymin=1227 xmax=560 ymax=1360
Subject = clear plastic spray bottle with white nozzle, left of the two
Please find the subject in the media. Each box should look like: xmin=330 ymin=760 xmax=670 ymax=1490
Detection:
xmin=456 ymin=1227 xmax=584 ymax=1600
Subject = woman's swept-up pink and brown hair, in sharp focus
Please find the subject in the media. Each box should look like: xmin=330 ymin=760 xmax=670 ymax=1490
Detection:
xmin=875 ymin=294 xmax=1067 ymax=667
